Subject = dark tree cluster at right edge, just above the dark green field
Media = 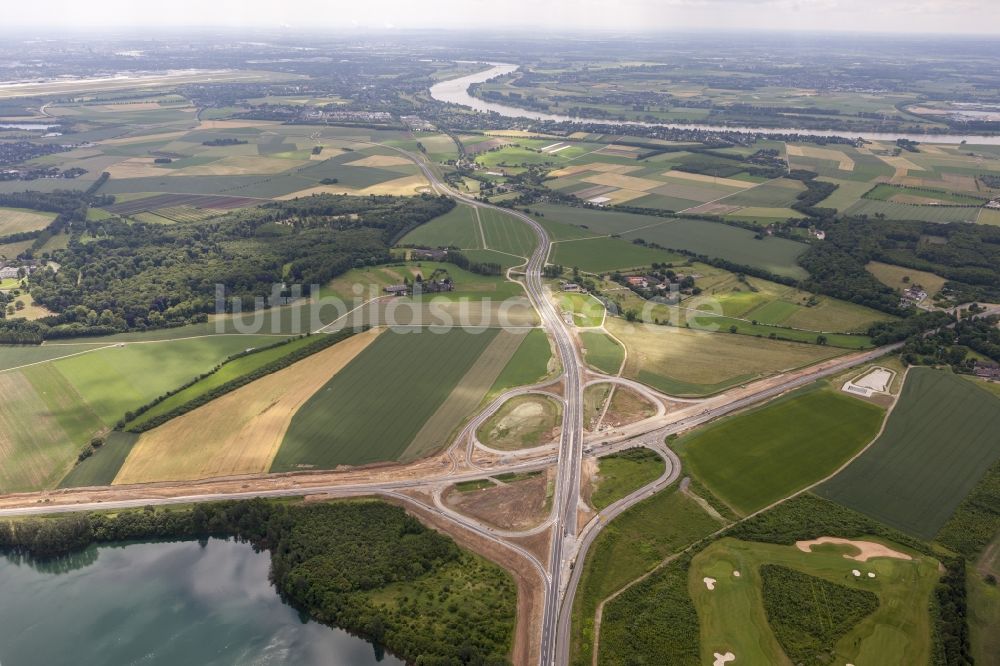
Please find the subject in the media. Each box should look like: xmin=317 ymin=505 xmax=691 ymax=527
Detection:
xmin=902 ymin=316 xmax=1000 ymax=372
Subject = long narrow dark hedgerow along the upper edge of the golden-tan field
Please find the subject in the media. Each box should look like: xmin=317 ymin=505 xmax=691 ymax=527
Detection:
xmin=123 ymin=327 xmax=367 ymax=432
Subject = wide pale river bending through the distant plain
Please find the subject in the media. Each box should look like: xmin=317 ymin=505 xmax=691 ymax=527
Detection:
xmin=431 ymin=62 xmax=1000 ymax=146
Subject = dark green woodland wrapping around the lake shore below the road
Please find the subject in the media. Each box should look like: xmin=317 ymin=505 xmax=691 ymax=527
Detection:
xmin=0 ymin=499 xmax=516 ymax=666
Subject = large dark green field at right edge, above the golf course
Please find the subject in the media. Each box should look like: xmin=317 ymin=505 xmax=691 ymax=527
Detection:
xmin=817 ymin=368 xmax=1000 ymax=539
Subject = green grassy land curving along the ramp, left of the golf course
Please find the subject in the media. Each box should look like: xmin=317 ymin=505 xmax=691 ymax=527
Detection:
xmin=570 ymin=485 xmax=722 ymax=666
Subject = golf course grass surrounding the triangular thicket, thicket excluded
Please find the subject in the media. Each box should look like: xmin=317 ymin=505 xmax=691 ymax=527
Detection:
xmin=688 ymin=538 xmax=939 ymax=664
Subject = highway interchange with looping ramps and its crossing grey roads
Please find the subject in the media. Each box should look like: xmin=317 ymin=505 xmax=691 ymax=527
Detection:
xmin=0 ymin=141 xmax=916 ymax=665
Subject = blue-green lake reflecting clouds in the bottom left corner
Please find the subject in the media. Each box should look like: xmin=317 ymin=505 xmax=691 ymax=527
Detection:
xmin=0 ymin=539 xmax=403 ymax=666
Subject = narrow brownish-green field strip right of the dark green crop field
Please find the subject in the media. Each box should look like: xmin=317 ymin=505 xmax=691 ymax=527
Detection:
xmin=399 ymin=331 xmax=524 ymax=462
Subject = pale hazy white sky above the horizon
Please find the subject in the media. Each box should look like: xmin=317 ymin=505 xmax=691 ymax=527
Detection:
xmin=0 ymin=0 xmax=1000 ymax=36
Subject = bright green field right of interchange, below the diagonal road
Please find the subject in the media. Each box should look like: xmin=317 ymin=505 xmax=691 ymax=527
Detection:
xmin=678 ymin=384 xmax=884 ymax=515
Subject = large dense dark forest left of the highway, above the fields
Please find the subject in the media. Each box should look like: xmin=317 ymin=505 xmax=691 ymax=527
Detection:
xmin=0 ymin=195 xmax=454 ymax=342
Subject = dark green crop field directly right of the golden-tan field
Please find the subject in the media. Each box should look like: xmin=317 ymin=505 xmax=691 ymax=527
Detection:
xmin=271 ymin=329 xmax=498 ymax=472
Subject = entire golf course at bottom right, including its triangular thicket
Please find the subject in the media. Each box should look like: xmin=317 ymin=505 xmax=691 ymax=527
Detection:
xmin=688 ymin=539 xmax=939 ymax=664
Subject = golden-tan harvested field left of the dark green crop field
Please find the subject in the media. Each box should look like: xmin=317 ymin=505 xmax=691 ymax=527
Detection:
xmin=114 ymin=329 xmax=381 ymax=485
